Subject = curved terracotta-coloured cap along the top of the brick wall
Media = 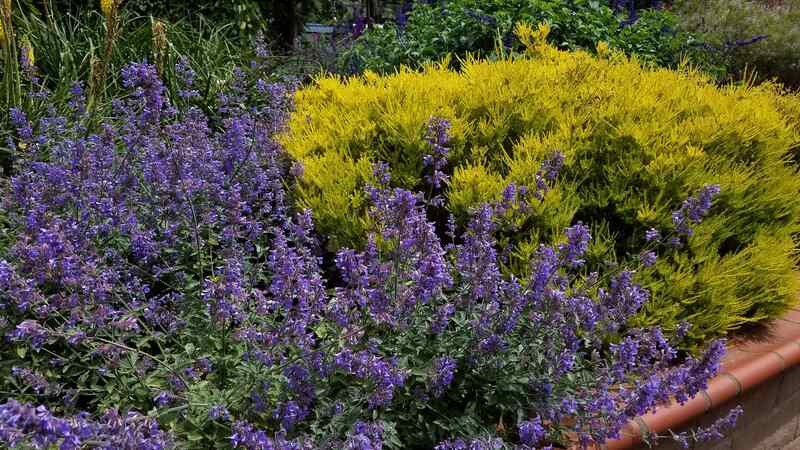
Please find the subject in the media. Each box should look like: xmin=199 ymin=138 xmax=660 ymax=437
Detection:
xmin=584 ymin=307 xmax=800 ymax=450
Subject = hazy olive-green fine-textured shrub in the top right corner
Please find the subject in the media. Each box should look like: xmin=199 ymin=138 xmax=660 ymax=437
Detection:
xmin=674 ymin=0 xmax=800 ymax=87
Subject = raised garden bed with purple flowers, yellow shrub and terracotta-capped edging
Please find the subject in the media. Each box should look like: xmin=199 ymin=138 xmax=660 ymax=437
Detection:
xmin=0 ymin=0 xmax=800 ymax=450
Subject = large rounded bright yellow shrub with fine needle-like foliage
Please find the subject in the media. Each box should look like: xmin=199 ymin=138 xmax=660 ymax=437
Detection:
xmin=283 ymin=36 xmax=800 ymax=348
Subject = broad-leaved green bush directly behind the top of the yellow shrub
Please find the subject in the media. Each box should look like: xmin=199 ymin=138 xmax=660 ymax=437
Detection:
xmin=343 ymin=0 xmax=720 ymax=72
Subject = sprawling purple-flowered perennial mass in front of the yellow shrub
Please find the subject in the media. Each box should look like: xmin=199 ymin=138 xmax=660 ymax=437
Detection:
xmin=0 ymin=53 xmax=740 ymax=450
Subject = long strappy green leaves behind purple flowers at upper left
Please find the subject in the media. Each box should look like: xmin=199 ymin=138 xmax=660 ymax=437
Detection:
xmin=2 ymin=8 xmax=244 ymax=110
